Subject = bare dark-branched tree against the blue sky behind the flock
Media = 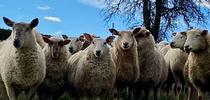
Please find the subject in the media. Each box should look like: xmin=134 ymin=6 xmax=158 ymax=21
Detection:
xmin=102 ymin=0 xmax=209 ymax=42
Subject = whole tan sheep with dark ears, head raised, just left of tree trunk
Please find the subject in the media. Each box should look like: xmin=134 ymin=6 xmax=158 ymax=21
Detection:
xmin=109 ymin=29 xmax=140 ymax=98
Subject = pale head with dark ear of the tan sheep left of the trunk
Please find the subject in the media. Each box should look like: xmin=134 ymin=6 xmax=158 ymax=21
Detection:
xmin=109 ymin=29 xmax=135 ymax=50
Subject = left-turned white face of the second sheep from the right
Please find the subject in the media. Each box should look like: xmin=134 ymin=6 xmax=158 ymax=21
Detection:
xmin=170 ymin=32 xmax=187 ymax=49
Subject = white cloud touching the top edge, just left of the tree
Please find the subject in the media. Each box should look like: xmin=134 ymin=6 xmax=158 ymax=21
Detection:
xmin=79 ymin=0 xmax=105 ymax=9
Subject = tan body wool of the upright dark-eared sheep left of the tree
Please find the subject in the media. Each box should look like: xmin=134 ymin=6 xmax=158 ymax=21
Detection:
xmin=111 ymin=31 xmax=139 ymax=87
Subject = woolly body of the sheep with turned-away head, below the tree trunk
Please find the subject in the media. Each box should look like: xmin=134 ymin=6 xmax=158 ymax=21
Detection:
xmin=137 ymin=35 xmax=168 ymax=88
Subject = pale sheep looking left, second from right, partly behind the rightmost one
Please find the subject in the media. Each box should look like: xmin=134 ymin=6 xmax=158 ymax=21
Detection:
xmin=164 ymin=32 xmax=188 ymax=95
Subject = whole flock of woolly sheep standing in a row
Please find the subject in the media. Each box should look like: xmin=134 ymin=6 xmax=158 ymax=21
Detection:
xmin=0 ymin=17 xmax=210 ymax=100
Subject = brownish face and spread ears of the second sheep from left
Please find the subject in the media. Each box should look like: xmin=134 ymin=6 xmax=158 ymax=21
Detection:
xmin=43 ymin=37 xmax=70 ymax=58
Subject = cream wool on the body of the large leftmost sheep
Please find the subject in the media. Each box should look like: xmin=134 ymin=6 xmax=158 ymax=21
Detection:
xmin=0 ymin=30 xmax=46 ymax=99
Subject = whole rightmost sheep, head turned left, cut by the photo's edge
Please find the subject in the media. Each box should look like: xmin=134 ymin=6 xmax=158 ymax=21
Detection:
xmin=184 ymin=29 xmax=210 ymax=100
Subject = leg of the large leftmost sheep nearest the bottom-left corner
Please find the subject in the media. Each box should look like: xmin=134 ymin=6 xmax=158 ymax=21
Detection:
xmin=5 ymin=85 xmax=17 ymax=100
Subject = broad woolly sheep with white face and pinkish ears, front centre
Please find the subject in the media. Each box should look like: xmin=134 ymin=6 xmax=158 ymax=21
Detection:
xmin=69 ymin=35 xmax=116 ymax=100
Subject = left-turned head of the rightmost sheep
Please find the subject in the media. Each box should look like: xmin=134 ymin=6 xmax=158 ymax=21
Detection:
xmin=184 ymin=29 xmax=208 ymax=52
